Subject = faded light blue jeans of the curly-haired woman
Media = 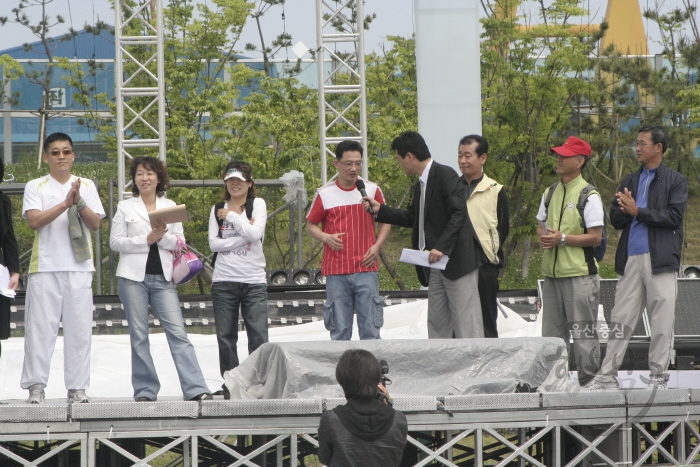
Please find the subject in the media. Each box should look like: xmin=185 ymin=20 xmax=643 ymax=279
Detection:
xmin=119 ymin=274 xmax=211 ymax=400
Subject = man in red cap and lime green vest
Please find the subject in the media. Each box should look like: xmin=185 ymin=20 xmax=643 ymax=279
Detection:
xmin=537 ymin=136 xmax=605 ymax=387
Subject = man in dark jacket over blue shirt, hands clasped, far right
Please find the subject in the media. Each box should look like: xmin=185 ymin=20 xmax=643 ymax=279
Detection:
xmin=591 ymin=125 xmax=688 ymax=389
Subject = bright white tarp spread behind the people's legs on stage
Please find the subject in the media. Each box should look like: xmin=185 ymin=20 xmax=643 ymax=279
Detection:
xmin=0 ymin=300 xmax=541 ymax=401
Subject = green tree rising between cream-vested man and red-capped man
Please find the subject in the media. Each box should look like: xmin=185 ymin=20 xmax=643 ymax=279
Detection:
xmin=481 ymin=0 xmax=598 ymax=277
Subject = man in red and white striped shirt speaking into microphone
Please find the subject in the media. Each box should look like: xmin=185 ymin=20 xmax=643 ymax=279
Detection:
xmin=306 ymin=141 xmax=391 ymax=340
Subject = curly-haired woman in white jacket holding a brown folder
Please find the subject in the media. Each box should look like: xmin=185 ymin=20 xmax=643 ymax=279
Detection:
xmin=109 ymin=157 xmax=212 ymax=401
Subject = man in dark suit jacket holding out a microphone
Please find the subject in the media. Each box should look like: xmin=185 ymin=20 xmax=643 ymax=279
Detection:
xmin=364 ymin=131 xmax=484 ymax=339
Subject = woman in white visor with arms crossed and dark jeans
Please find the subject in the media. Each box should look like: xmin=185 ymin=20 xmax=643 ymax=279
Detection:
xmin=209 ymin=161 xmax=267 ymax=398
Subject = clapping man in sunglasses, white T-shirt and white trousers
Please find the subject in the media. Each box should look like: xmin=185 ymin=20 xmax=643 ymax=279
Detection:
xmin=21 ymin=133 xmax=105 ymax=404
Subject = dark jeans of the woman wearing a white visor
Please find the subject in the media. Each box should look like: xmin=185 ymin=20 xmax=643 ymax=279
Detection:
xmin=211 ymin=281 xmax=268 ymax=376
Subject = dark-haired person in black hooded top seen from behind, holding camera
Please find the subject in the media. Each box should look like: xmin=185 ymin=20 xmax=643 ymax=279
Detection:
xmin=318 ymin=349 xmax=408 ymax=467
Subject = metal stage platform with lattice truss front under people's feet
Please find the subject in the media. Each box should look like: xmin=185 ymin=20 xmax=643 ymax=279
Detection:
xmin=5 ymin=389 xmax=700 ymax=467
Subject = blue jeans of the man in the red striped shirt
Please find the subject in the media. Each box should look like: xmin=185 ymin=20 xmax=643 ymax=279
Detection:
xmin=323 ymin=272 xmax=384 ymax=341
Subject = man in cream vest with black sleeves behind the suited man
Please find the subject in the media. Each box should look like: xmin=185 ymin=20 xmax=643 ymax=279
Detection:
xmin=457 ymin=135 xmax=510 ymax=337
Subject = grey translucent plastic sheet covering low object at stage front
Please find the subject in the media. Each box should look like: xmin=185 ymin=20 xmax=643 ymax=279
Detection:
xmin=224 ymin=337 xmax=571 ymax=399
